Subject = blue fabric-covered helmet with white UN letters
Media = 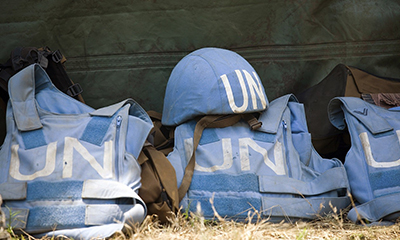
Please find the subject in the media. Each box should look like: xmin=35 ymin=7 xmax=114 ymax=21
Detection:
xmin=162 ymin=48 xmax=269 ymax=126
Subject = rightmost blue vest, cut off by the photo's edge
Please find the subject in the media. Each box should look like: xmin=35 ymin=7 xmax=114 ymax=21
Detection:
xmin=329 ymin=97 xmax=400 ymax=222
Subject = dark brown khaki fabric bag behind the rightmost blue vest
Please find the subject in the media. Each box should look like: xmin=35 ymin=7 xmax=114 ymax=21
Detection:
xmin=297 ymin=64 xmax=400 ymax=161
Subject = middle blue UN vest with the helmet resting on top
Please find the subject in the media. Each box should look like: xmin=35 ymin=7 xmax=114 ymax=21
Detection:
xmin=168 ymin=95 xmax=350 ymax=221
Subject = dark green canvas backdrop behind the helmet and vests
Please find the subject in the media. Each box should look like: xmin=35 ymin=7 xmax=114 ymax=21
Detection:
xmin=0 ymin=0 xmax=400 ymax=142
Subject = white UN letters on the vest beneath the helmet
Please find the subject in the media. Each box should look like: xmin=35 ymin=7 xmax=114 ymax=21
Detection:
xmin=184 ymin=138 xmax=286 ymax=175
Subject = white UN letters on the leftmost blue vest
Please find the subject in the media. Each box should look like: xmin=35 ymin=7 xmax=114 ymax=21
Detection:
xmin=9 ymin=137 xmax=114 ymax=181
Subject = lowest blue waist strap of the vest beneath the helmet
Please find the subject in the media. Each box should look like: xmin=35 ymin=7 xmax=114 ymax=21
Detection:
xmin=189 ymin=194 xmax=350 ymax=221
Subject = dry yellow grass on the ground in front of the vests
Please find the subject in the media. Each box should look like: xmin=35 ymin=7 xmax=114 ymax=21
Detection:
xmin=8 ymin=207 xmax=400 ymax=240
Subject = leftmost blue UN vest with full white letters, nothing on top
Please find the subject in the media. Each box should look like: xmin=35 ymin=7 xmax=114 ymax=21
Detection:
xmin=0 ymin=64 xmax=152 ymax=239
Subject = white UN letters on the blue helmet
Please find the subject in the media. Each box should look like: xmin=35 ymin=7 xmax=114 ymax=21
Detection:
xmin=220 ymin=70 xmax=267 ymax=113
